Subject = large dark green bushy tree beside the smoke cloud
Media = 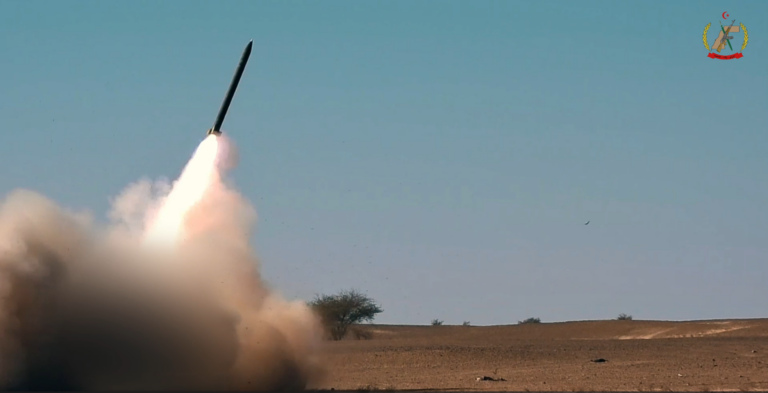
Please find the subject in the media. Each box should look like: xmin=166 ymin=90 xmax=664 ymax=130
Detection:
xmin=309 ymin=289 xmax=384 ymax=341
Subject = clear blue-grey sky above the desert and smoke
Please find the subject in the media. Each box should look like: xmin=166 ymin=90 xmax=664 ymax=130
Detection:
xmin=0 ymin=1 xmax=768 ymax=325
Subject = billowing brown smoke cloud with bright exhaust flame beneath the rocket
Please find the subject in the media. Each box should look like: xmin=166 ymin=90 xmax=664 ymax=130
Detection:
xmin=0 ymin=136 xmax=322 ymax=391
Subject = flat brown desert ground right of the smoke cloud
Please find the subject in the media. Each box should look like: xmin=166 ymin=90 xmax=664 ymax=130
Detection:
xmin=314 ymin=319 xmax=768 ymax=391
